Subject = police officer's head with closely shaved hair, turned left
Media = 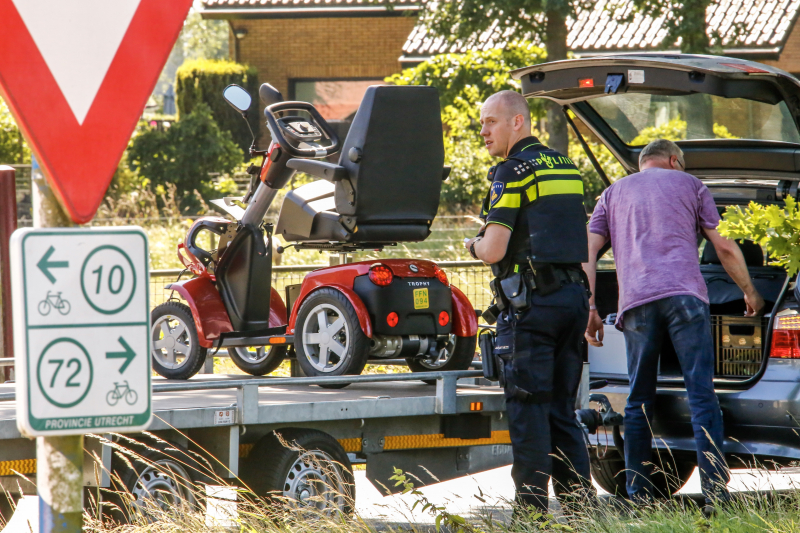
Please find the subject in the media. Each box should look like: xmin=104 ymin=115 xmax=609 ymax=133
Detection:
xmin=481 ymin=91 xmax=531 ymax=157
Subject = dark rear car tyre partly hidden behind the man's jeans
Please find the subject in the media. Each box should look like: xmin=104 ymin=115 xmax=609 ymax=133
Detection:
xmin=591 ymin=452 xmax=695 ymax=498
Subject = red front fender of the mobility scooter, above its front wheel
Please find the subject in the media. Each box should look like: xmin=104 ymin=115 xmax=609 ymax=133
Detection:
xmin=165 ymin=276 xmax=233 ymax=348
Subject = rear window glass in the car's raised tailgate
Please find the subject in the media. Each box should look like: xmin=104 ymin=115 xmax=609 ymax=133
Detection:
xmin=589 ymin=93 xmax=800 ymax=146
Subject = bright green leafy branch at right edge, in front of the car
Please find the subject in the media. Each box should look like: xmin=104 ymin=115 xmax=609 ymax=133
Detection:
xmin=717 ymin=196 xmax=800 ymax=276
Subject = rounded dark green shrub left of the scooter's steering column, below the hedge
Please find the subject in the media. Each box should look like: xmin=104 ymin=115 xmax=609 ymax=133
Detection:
xmin=128 ymin=102 xmax=242 ymax=210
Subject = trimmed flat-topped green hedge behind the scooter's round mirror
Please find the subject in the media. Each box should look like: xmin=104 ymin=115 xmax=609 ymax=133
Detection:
xmin=175 ymin=59 xmax=262 ymax=154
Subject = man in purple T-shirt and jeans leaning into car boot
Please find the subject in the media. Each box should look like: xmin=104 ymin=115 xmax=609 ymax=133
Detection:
xmin=584 ymin=139 xmax=764 ymax=503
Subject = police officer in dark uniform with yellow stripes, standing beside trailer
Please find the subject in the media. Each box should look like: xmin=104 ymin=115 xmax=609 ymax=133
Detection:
xmin=465 ymin=91 xmax=592 ymax=514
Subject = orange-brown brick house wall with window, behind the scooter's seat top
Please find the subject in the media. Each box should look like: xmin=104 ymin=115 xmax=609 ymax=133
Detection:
xmin=203 ymin=0 xmax=420 ymax=120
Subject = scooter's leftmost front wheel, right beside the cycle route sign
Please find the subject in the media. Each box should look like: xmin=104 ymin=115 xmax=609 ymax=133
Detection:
xmin=150 ymin=302 xmax=208 ymax=379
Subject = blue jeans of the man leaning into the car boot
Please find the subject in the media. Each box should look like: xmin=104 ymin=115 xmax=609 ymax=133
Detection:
xmin=623 ymin=296 xmax=730 ymax=500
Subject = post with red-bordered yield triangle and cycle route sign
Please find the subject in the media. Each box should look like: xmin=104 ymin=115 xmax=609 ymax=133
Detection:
xmin=0 ymin=0 xmax=192 ymax=533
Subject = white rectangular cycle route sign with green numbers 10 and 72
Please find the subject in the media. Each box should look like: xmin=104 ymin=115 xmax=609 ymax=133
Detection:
xmin=10 ymin=227 xmax=151 ymax=436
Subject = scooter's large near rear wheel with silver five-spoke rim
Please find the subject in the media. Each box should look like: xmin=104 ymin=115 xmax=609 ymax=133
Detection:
xmin=295 ymin=289 xmax=370 ymax=380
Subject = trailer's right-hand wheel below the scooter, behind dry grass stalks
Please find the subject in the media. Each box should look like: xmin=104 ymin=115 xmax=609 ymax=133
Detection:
xmin=240 ymin=428 xmax=356 ymax=516
